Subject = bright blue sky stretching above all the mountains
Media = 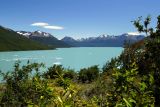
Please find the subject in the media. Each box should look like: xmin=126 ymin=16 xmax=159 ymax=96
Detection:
xmin=0 ymin=0 xmax=160 ymax=38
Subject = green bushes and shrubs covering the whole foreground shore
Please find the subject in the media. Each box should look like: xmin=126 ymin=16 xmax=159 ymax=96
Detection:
xmin=0 ymin=16 xmax=160 ymax=107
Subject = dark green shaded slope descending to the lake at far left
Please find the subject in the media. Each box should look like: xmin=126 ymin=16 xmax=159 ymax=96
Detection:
xmin=0 ymin=26 xmax=51 ymax=51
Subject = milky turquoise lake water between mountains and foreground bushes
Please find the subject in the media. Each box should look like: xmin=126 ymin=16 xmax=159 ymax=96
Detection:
xmin=0 ymin=47 xmax=123 ymax=71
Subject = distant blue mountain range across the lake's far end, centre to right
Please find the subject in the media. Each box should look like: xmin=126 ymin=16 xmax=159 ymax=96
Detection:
xmin=62 ymin=33 xmax=145 ymax=47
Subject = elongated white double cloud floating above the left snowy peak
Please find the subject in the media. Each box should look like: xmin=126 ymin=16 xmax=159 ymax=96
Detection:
xmin=31 ymin=22 xmax=64 ymax=30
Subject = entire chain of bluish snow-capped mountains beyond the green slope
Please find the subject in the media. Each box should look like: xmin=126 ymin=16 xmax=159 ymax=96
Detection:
xmin=17 ymin=31 xmax=145 ymax=47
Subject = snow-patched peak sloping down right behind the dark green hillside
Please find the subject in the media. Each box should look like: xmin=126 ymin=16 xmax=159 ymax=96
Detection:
xmin=17 ymin=31 xmax=70 ymax=48
